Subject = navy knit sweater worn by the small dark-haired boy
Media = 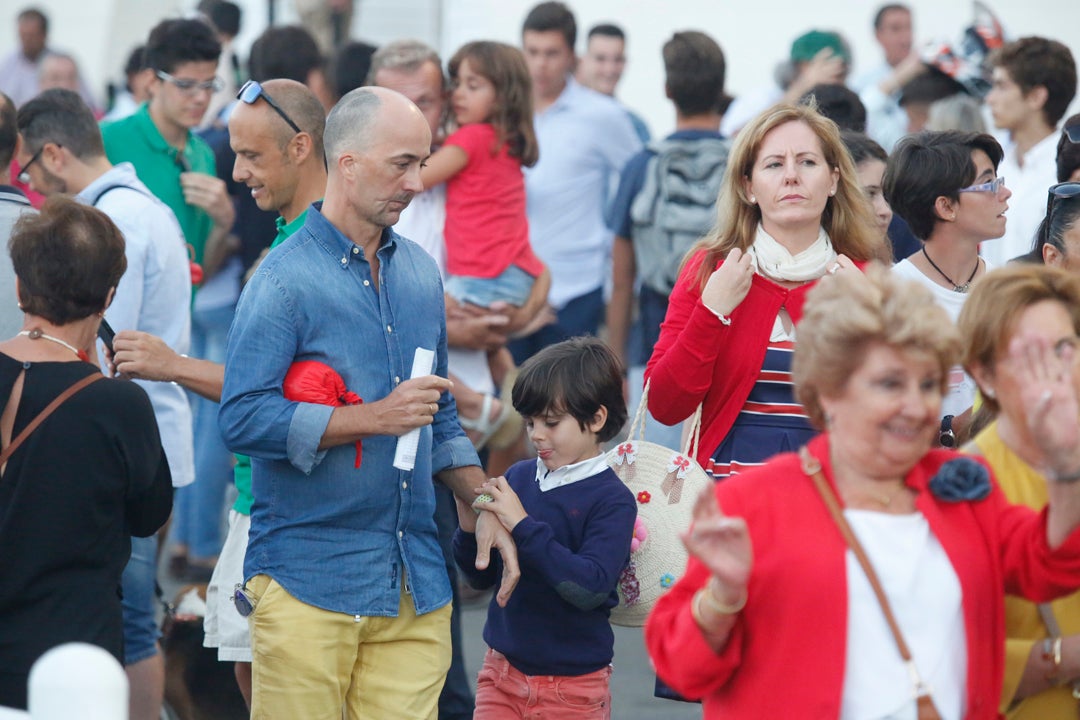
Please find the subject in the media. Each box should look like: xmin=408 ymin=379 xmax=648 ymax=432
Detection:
xmin=454 ymin=460 xmax=637 ymax=676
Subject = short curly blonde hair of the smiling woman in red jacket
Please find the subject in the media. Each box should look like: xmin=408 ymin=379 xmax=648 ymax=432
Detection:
xmin=792 ymin=262 xmax=960 ymax=430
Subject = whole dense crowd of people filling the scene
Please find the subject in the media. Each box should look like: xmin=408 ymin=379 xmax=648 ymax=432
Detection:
xmin=0 ymin=0 xmax=1080 ymax=720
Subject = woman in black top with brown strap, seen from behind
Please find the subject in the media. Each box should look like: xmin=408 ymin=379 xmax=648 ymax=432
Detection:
xmin=0 ymin=198 xmax=173 ymax=708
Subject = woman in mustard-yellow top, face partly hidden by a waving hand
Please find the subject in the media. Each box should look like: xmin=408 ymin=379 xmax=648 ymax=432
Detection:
xmin=959 ymin=264 xmax=1080 ymax=720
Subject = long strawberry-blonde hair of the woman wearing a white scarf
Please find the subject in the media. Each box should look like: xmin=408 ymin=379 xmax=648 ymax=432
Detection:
xmin=687 ymin=105 xmax=892 ymax=288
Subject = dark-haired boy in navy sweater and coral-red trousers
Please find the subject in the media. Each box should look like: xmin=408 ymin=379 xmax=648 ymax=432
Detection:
xmin=454 ymin=338 xmax=637 ymax=720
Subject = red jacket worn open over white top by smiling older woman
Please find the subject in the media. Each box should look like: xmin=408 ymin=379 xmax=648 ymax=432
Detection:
xmin=645 ymin=435 xmax=1080 ymax=720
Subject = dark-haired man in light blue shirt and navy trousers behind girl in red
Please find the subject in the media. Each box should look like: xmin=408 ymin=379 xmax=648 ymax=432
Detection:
xmin=510 ymin=2 xmax=642 ymax=363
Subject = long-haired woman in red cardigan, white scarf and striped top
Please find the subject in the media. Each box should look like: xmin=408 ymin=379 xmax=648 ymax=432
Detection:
xmin=646 ymin=101 xmax=888 ymax=479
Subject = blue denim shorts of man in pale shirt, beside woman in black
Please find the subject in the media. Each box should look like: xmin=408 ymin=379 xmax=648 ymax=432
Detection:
xmin=120 ymin=535 xmax=161 ymax=665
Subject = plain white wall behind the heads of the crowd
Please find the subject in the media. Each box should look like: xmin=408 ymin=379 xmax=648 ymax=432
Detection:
xmin=0 ymin=0 xmax=1080 ymax=135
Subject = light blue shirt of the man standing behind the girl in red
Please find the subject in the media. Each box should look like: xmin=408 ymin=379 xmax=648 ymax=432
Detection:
xmin=525 ymin=78 xmax=642 ymax=309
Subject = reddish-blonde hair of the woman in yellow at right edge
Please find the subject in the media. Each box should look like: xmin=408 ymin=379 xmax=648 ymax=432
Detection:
xmin=957 ymin=262 xmax=1080 ymax=412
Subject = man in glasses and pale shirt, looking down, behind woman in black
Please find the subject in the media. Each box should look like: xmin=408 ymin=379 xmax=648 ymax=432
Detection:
xmin=17 ymin=89 xmax=194 ymax=719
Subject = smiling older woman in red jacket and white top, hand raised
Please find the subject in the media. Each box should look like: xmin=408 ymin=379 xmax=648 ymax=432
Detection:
xmin=645 ymin=268 xmax=1080 ymax=720
